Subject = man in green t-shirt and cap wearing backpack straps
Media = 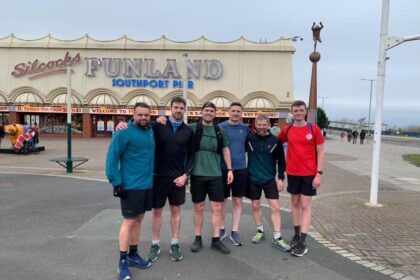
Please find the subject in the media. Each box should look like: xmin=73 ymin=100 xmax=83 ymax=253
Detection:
xmin=190 ymin=102 xmax=233 ymax=254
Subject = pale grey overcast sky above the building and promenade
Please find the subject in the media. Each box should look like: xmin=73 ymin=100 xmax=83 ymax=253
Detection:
xmin=0 ymin=0 xmax=420 ymax=126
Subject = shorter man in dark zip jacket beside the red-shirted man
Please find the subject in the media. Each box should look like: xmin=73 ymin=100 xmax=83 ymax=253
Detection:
xmin=246 ymin=115 xmax=290 ymax=252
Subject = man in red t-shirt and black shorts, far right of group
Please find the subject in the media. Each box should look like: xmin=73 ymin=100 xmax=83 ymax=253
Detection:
xmin=279 ymin=100 xmax=324 ymax=257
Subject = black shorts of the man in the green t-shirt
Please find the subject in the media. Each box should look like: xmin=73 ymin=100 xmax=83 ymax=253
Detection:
xmin=191 ymin=176 xmax=225 ymax=203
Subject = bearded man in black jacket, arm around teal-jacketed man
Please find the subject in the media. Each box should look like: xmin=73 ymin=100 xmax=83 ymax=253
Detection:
xmin=117 ymin=97 xmax=194 ymax=261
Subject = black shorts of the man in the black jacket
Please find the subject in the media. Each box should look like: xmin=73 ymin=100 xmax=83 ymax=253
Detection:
xmin=152 ymin=176 xmax=185 ymax=208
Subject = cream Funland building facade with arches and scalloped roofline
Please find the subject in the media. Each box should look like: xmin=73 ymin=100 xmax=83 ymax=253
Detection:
xmin=0 ymin=35 xmax=295 ymax=137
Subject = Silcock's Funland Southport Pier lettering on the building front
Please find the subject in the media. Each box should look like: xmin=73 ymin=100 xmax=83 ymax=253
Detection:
xmin=11 ymin=52 xmax=223 ymax=88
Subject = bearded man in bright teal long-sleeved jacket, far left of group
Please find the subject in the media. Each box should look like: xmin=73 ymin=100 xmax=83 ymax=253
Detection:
xmin=106 ymin=102 xmax=155 ymax=280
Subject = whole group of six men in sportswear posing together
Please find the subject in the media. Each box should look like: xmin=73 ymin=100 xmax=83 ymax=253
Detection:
xmin=106 ymin=97 xmax=324 ymax=279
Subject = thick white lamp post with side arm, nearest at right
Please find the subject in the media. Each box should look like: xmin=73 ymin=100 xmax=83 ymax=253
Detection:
xmin=367 ymin=0 xmax=420 ymax=206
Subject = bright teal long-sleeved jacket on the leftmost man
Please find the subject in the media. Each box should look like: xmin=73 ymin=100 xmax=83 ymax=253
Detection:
xmin=106 ymin=121 xmax=155 ymax=190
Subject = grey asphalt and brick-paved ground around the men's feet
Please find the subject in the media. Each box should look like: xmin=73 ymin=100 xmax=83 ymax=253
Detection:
xmin=0 ymin=135 xmax=420 ymax=280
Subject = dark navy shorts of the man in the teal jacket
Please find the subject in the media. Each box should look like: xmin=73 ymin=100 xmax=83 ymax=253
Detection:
xmin=120 ymin=188 xmax=152 ymax=219
